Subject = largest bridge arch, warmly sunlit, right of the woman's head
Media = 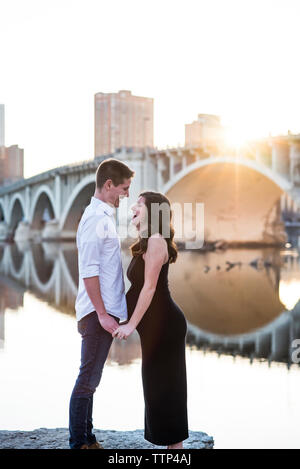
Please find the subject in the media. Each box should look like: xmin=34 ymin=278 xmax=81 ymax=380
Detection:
xmin=162 ymin=156 xmax=292 ymax=245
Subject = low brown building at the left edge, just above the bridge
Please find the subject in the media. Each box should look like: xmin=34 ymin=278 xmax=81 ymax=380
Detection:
xmin=0 ymin=145 xmax=24 ymax=184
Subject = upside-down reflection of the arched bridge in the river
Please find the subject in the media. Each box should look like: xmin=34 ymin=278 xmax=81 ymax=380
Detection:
xmin=0 ymin=239 xmax=300 ymax=366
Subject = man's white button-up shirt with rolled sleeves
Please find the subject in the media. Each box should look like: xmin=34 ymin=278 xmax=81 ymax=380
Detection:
xmin=75 ymin=197 xmax=128 ymax=321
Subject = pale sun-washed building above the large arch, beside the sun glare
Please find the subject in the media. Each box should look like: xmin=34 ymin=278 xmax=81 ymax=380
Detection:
xmin=185 ymin=114 xmax=223 ymax=149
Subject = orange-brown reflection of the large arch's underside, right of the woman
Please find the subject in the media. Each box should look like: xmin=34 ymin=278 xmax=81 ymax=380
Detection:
xmin=170 ymin=249 xmax=285 ymax=335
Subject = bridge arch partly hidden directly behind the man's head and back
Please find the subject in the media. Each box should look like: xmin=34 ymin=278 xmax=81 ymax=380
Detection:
xmin=60 ymin=174 xmax=95 ymax=233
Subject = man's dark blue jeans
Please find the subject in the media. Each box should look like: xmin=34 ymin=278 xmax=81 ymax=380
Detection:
xmin=69 ymin=311 xmax=120 ymax=449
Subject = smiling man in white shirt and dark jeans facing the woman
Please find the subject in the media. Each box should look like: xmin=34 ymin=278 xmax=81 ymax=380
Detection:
xmin=69 ymin=158 xmax=134 ymax=449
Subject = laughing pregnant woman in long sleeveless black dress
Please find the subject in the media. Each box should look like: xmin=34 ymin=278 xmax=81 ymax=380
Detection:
xmin=113 ymin=191 xmax=189 ymax=449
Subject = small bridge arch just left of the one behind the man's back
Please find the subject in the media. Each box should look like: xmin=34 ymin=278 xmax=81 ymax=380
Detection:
xmin=29 ymin=185 xmax=56 ymax=229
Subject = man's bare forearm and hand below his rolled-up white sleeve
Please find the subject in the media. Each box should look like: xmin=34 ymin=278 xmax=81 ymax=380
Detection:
xmin=83 ymin=276 xmax=119 ymax=334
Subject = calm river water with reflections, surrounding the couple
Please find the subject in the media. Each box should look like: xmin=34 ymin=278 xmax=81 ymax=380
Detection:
xmin=0 ymin=239 xmax=300 ymax=448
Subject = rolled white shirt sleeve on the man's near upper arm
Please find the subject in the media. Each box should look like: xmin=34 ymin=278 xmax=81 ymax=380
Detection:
xmin=78 ymin=215 xmax=104 ymax=278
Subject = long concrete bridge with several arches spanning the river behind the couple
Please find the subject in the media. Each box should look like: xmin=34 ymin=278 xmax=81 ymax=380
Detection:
xmin=0 ymin=142 xmax=300 ymax=244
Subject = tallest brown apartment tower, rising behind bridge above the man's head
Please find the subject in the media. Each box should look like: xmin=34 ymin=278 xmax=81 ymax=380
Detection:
xmin=95 ymin=90 xmax=154 ymax=156
